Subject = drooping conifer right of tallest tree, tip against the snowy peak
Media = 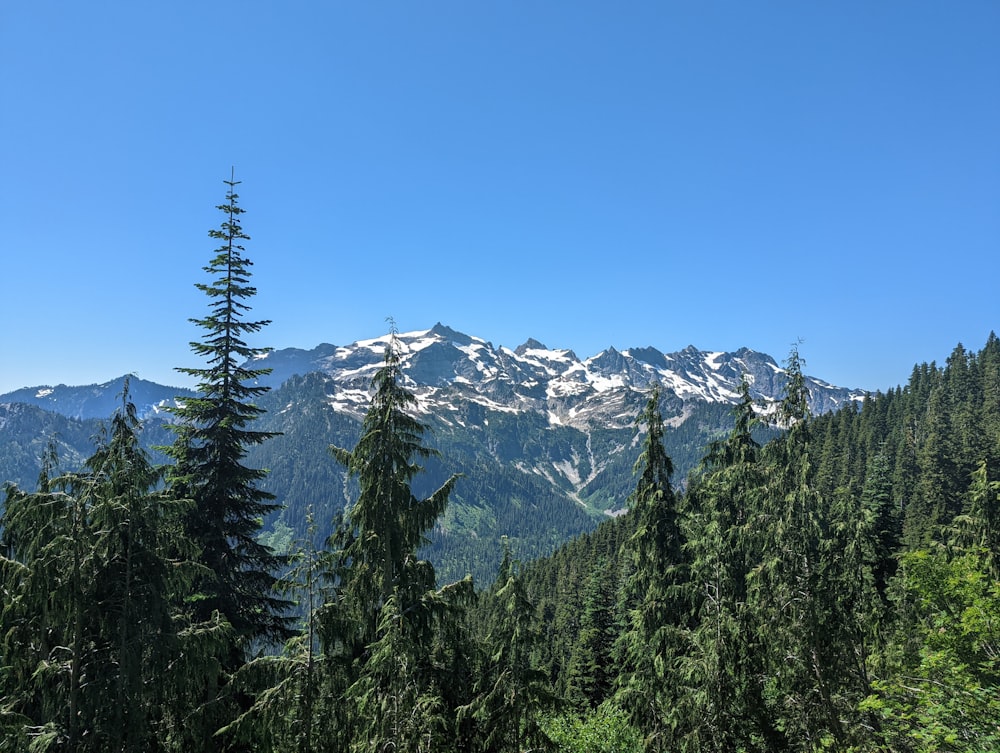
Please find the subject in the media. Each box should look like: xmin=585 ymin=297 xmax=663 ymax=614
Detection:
xmin=323 ymin=327 xmax=472 ymax=751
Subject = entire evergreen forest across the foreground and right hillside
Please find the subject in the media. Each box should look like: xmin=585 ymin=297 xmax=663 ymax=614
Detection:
xmin=0 ymin=179 xmax=1000 ymax=753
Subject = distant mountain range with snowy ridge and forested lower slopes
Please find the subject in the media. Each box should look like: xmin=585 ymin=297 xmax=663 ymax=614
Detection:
xmin=0 ymin=324 xmax=863 ymax=582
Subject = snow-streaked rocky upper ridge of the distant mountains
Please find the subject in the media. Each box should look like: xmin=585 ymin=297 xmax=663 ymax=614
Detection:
xmin=254 ymin=324 xmax=864 ymax=429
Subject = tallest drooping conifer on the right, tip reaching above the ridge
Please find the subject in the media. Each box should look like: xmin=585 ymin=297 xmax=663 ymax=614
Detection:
xmin=748 ymin=347 xmax=870 ymax=749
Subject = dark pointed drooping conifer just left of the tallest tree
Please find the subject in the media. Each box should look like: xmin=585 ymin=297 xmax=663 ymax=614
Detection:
xmin=76 ymin=379 xmax=183 ymax=751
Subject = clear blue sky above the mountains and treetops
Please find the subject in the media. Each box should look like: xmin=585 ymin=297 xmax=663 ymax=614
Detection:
xmin=0 ymin=0 xmax=1000 ymax=393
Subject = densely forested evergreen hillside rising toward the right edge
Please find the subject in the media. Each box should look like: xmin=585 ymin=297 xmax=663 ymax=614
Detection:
xmin=508 ymin=335 xmax=1000 ymax=751
